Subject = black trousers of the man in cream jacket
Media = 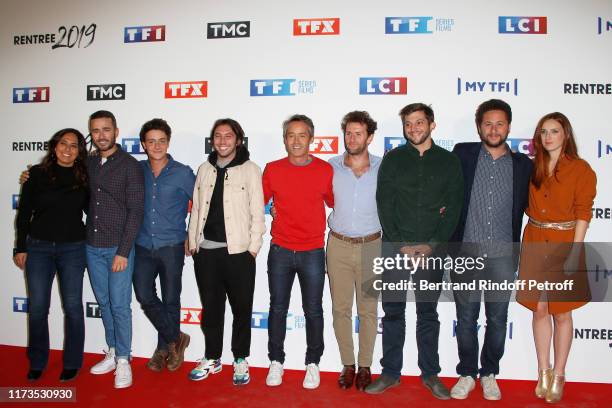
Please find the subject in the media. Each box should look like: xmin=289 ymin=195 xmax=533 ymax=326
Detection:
xmin=193 ymin=248 xmax=255 ymax=360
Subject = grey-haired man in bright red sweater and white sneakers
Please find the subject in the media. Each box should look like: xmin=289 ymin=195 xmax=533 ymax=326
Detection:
xmin=263 ymin=115 xmax=334 ymax=389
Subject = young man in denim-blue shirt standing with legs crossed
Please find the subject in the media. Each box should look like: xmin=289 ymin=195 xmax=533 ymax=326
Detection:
xmin=133 ymin=119 xmax=195 ymax=371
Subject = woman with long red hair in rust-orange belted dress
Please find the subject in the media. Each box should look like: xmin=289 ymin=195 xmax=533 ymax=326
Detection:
xmin=518 ymin=112 xmax=596 ymax=402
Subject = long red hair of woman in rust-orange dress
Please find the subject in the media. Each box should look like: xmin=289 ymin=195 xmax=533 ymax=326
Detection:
xmin=531 ymin=112 xmax=579 ymax=189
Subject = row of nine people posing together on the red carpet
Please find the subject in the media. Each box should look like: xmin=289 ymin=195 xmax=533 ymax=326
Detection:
xmin=14 ymin=99 xmax=595 ymax=402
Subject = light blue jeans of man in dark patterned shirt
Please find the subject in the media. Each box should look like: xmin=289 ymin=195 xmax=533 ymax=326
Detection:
xmin=86 ymin=245 xmax=134 ymax=359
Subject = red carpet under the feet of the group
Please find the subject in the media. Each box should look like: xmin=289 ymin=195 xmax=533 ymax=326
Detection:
xmin=0 ymin=346 xmax=612 ymax=408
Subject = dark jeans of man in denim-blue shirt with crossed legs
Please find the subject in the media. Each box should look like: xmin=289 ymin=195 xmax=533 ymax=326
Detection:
xmin=133 ymin=243 xmax=185 ymax=350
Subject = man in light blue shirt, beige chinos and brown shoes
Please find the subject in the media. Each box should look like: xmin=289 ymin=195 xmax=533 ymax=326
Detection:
xmin=327 ymin=111 xmax=382 ymax=391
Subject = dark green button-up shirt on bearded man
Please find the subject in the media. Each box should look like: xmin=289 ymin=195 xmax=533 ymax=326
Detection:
xmin=376 ymin=139 xmax=463 ymax=246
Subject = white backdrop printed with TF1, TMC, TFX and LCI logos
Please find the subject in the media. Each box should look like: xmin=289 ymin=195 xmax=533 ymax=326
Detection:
xmin=0 ymin=0 xmax=612 ymax=382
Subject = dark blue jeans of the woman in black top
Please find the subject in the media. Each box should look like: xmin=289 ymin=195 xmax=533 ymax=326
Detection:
xmin=25 ymin=238 xmax=85 ymax=370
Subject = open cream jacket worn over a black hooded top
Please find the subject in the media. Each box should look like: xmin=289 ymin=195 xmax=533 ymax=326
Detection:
xmin=188 ymin=160 xmax=266 ymax=254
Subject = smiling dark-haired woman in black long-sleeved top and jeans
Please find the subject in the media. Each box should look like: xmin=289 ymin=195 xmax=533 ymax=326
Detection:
xmin=13 ymin=129 xmax=88 ymax=381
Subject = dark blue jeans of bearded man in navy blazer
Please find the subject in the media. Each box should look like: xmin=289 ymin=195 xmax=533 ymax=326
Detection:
xmin=451 ymin=257 xmax=515 ymax=378
